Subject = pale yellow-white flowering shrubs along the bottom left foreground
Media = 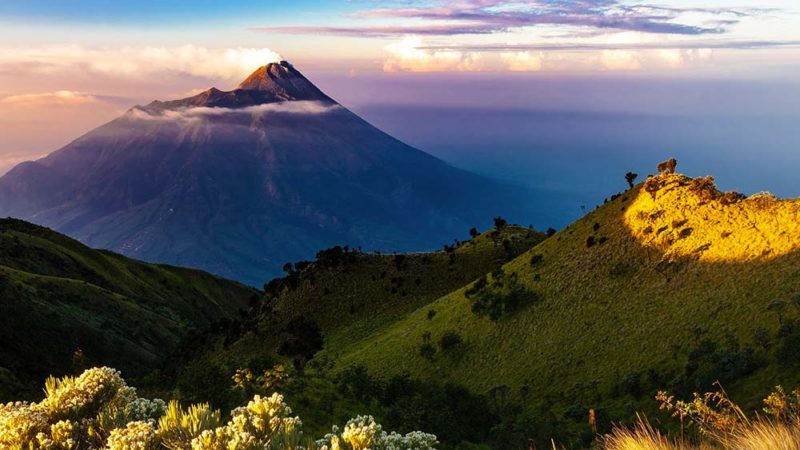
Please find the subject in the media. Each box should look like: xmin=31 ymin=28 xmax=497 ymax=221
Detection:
xmin=0 ymin=367 xmax=437 ymax=450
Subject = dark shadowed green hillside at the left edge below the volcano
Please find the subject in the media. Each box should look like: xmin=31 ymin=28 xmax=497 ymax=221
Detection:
xmin=0 ymin=219 xmax=257 ymax=399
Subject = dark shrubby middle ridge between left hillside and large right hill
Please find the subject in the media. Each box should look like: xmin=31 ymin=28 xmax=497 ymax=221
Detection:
xmin=161 ymin=225 xmax=546 ymax=427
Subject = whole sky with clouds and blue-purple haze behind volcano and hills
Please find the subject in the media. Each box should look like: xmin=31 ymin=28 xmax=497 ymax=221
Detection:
xmin=0 ymin=0 xmax=800 ymax=223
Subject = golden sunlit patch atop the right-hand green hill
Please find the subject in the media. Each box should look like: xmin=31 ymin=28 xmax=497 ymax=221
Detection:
xmin=624 ymin=175 xmax=800 ymax=262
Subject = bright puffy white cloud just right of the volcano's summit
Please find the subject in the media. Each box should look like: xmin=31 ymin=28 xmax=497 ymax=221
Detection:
xmin=383 ymin=36 xmax=481 ymax=72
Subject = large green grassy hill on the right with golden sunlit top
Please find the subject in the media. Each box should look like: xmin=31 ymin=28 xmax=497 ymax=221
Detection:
xmin=338 ymin=175 xmax=800 ymax=418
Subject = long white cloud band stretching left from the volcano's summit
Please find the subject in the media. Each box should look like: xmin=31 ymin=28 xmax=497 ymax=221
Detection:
xmin=0 ymin=45 xmax=281 ymax=79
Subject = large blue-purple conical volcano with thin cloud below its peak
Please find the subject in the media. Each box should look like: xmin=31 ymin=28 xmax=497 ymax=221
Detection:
xmin=0 ymin=62 xmax=538 ymax=285
